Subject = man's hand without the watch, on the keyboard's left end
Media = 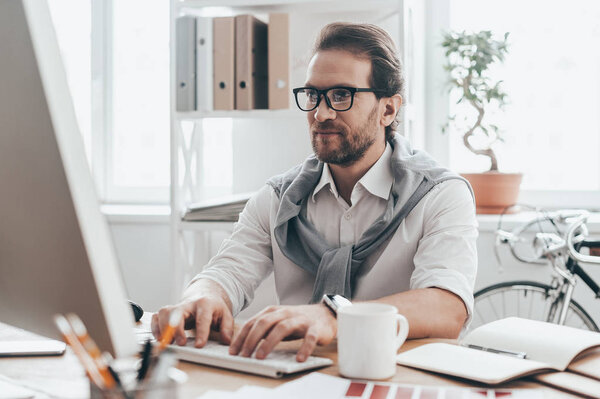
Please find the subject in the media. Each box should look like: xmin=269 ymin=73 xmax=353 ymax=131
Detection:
xmin=152 ymin=282 xmax=233 ymax=348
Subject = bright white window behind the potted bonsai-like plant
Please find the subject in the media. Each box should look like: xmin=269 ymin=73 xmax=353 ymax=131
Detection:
xmin=449 ymin=0 xmax=600 ymax=206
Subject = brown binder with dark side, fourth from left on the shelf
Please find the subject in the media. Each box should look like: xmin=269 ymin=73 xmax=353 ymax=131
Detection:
xmin=235 ymin=15 xmax=269 ymax=110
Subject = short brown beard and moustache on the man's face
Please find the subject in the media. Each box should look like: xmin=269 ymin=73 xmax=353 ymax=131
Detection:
xmin=311 ymin=106 xmax=378 ymax=167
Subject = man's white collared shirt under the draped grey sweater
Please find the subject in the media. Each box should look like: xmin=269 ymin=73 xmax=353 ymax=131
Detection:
xmin=190 ymin=145 xmax=478 ymax=319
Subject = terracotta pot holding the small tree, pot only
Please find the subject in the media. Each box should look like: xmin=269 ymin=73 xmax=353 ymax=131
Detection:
xmin=461 ymin=172 xmax=523 ymax=214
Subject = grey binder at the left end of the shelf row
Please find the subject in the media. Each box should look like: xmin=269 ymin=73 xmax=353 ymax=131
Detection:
xmin=175 ymin=16 xmax=196 ymax=112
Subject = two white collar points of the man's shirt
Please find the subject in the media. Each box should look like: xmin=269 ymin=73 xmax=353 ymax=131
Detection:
xmin=312 ymin=142 xmax=394 ymax=202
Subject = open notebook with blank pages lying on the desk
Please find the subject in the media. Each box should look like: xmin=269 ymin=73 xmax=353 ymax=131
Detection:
xmin=397 ymin=317 xmax=600 ymax=384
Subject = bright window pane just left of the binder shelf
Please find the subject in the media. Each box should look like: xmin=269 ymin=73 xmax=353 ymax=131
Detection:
xmin=108 ymin=0 xmax=170 ymax=192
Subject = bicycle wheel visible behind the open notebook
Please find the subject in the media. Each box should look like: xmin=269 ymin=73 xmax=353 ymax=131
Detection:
xmin=470 ymin=281 xmax=599 ymax=331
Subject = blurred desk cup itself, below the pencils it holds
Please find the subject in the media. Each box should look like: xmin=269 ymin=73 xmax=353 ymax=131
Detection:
xmin=90 ymin=368 xmax=187 ymax=399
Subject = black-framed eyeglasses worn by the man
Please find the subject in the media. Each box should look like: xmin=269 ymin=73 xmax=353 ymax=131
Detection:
xmin=292 ymin=86 xmax=381 ymax=112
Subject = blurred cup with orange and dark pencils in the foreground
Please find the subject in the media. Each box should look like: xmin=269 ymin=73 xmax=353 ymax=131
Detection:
xmin=54 ymin=314 xmax=187 ymax=399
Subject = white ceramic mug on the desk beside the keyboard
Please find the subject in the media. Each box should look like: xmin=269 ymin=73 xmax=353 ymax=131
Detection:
xmin=337 ymin=303 xmax=408 ymax=379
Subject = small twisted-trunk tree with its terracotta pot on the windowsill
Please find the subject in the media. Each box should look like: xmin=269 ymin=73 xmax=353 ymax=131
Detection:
xmin=442 ymin=31 xmax=523 ymax=213
